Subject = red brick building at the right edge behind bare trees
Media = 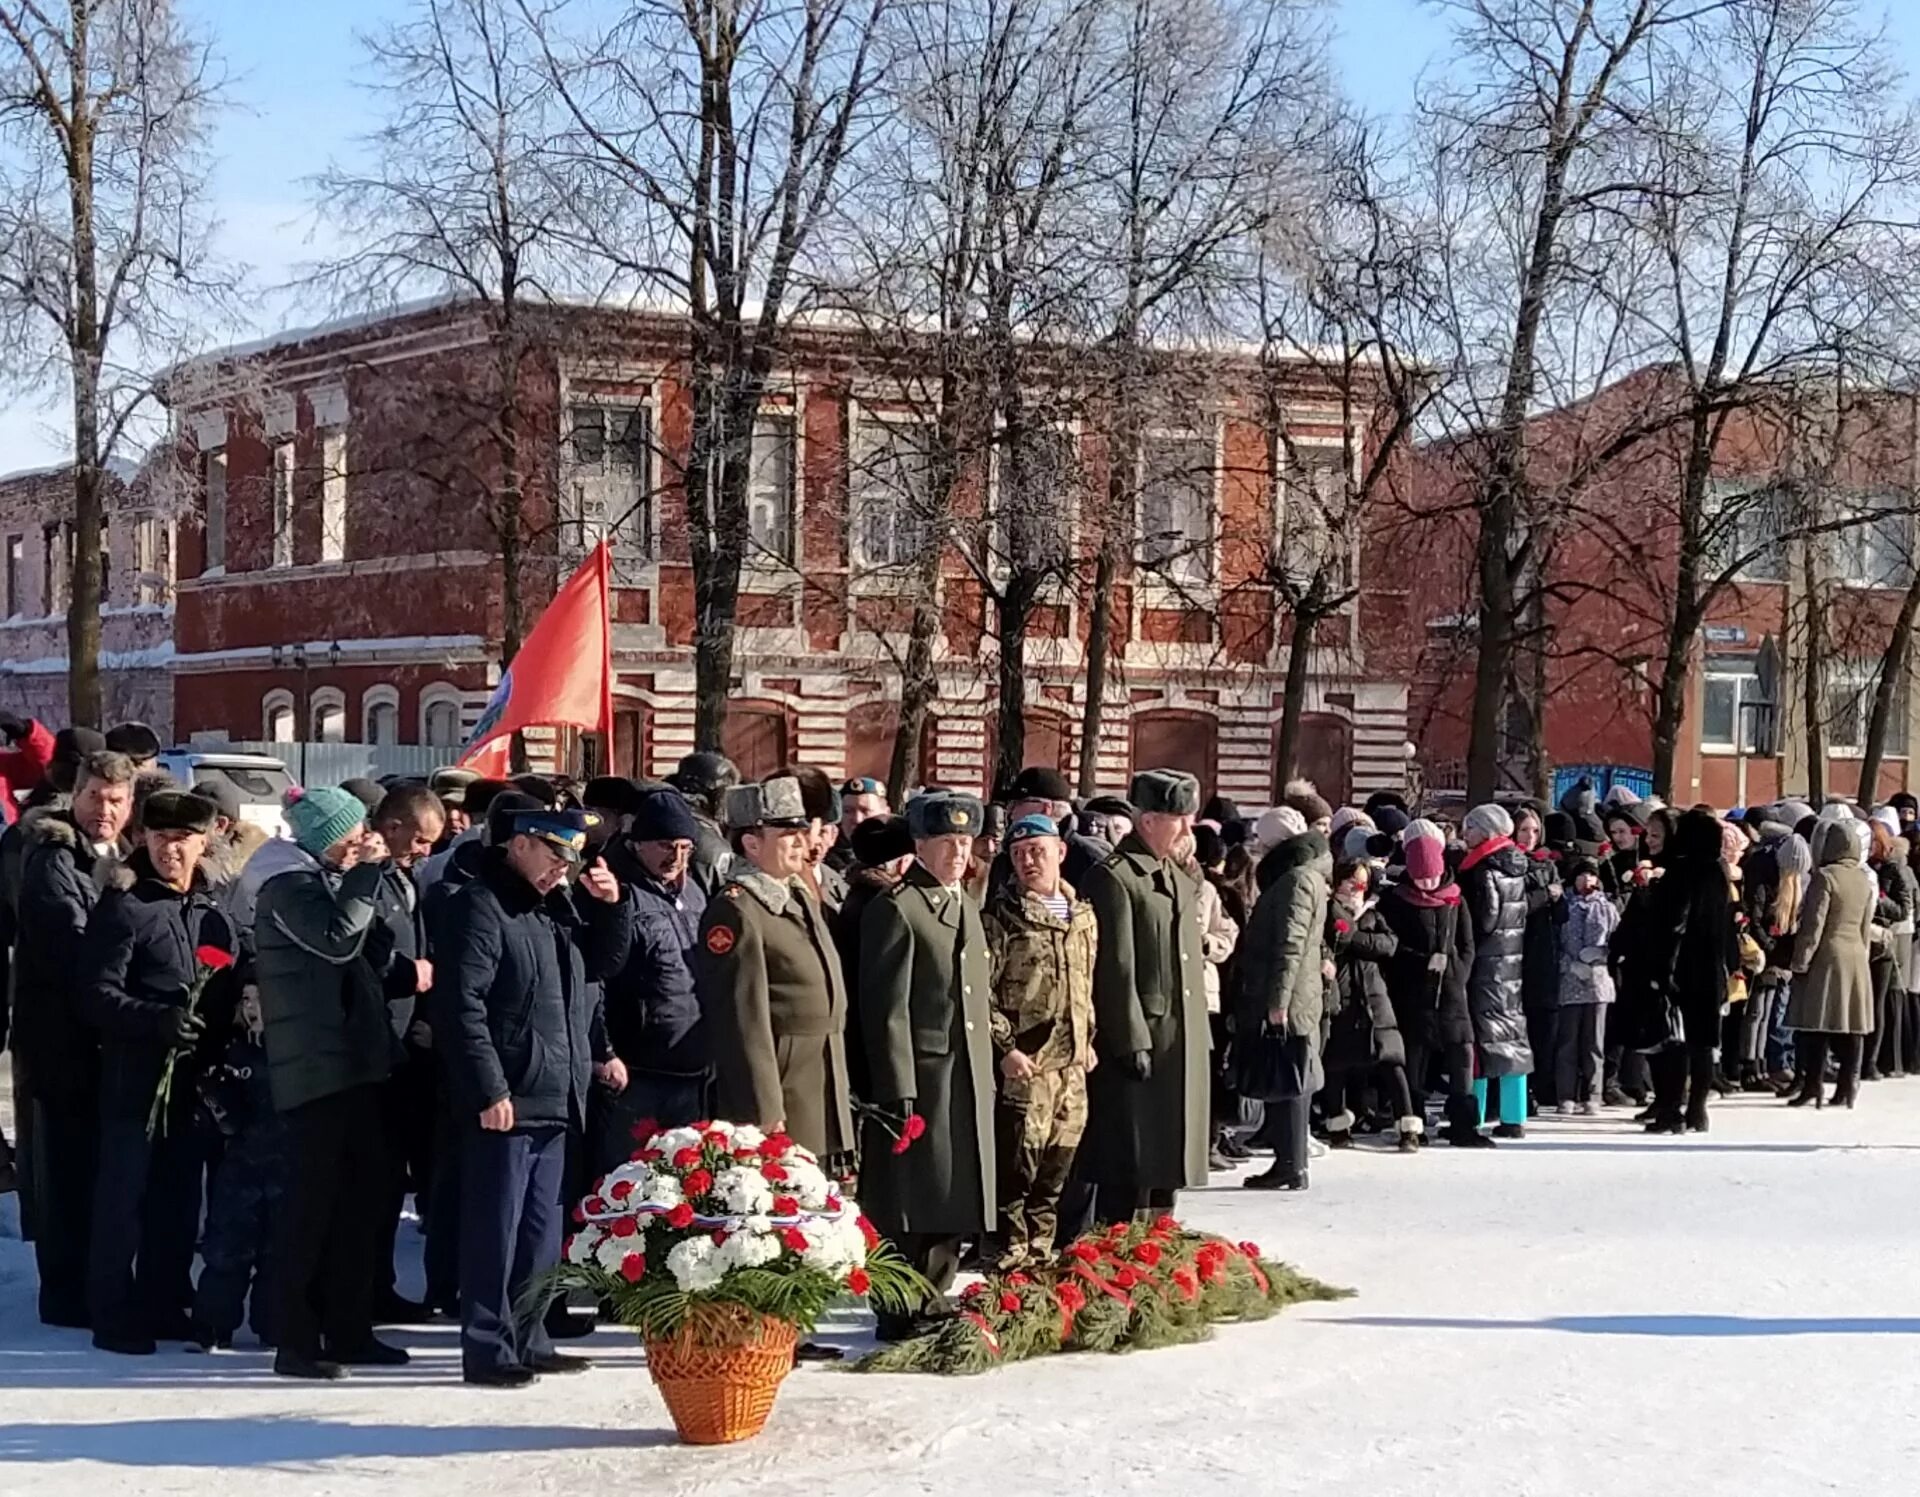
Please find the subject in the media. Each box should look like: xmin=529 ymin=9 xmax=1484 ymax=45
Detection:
xmin=1375 ymin=368 xmax=1920 ymax=806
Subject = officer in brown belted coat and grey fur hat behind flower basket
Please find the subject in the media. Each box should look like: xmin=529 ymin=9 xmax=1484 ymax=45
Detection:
xmin=693 ymin=775 xmax=852 ymax=1159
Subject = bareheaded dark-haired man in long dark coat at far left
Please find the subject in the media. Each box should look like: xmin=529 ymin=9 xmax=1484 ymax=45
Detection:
xmin=13 ymin=750 xmax=134 ymax=1328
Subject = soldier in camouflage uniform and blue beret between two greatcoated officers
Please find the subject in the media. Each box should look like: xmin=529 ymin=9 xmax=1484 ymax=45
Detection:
xmin=985 ymin=816 xmax=1098 ymax=1269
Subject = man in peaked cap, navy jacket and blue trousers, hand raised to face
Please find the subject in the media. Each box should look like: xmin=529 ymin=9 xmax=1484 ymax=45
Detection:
xmin=432 ymin=804 xmax=634 ymax=1388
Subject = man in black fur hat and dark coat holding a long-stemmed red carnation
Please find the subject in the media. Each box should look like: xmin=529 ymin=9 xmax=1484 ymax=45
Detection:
xmin=81 ymin=791 xmax=240 ymax=1355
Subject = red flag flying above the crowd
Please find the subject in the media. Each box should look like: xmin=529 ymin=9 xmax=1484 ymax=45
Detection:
xmin=461 ymin=541 xmax=612 ymax=779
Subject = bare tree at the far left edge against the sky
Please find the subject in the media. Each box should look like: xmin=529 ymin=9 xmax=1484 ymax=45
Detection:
xmin=0 ymin=0 xmax=230 ymax=725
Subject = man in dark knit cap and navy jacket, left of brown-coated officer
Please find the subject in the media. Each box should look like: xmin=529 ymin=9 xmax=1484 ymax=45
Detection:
xmin=593 ymin=789 xmax=712 ymax=1175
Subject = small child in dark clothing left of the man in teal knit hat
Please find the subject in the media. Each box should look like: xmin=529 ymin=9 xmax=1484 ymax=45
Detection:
xmin=194 ymin=988 xmax=286 ymax=1351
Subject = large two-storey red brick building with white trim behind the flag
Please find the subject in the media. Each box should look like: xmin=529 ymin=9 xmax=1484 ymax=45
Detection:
xmin=161 ymin=301 xmax=1407 ymax=808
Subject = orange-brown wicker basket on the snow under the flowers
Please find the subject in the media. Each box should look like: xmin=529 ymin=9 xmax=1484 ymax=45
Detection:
xmin=647 ymin=1311 xmax=797 ymax=1445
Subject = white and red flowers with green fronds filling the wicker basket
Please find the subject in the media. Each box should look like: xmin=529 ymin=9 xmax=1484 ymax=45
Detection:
xmin=555 ymin=1123 xmax=925 ymax=1336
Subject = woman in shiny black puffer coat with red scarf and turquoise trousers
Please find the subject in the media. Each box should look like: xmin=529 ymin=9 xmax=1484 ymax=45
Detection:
xmin=1459 ymin=804 xmax=1534 ymax=1138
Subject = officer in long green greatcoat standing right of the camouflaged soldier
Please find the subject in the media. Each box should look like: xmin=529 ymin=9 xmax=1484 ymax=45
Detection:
xmin=1079 ymin=770 xmax=1212 ymax=1221
